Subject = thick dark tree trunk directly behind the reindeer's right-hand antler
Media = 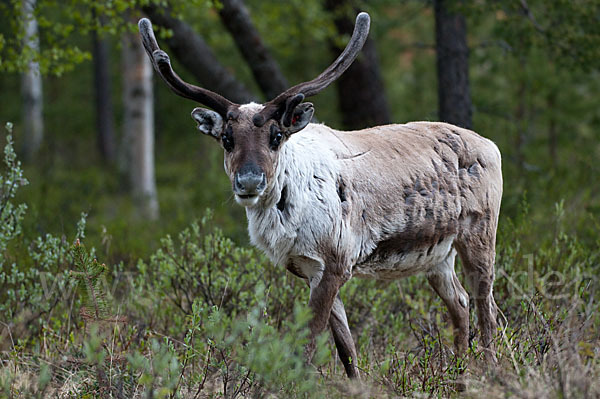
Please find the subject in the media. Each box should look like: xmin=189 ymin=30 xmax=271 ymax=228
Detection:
xmin=325 ymin=0 xmax=391 ymax=129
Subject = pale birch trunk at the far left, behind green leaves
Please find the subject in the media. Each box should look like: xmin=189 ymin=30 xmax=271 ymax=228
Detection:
xmin=21 ymin=0 xmax=44 ymax=160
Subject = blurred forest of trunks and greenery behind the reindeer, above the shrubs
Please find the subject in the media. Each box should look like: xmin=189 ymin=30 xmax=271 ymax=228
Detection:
xmin=0 ymin=0 xmax=600 ymax=262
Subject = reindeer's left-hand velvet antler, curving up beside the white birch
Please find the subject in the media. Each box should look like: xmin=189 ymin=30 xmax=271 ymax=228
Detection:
xmin=138 ymin=18 xmax=234 ymax=116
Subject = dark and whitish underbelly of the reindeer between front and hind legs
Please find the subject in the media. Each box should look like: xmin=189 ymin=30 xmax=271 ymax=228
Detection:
xmin=352 ymin=235 xmax=455 ymax=280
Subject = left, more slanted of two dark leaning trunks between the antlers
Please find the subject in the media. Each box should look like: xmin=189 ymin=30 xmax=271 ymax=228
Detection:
xmin=143 ymin=5 xmax=256 ymax=104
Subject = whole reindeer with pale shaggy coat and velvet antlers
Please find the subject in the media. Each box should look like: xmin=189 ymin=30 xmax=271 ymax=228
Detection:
xmin=139 ymin=13 xmax=502 ymax=378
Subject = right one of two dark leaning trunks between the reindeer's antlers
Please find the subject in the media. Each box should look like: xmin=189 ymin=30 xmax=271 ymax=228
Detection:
xmin=219 ymin=0 xmax=288 ymax=100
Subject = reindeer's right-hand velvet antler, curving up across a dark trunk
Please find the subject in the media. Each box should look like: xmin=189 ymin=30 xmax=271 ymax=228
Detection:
xmin=253 ymin=12 xmax=371 ymax=126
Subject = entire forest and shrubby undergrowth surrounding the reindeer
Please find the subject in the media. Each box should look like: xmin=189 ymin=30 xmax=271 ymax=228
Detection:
xmin=0 ymin=0 xmax=600 ymax=397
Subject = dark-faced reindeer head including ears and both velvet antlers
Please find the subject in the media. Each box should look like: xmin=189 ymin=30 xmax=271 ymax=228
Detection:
xmin=138 ymin=12 xmax=370 ymax=206
